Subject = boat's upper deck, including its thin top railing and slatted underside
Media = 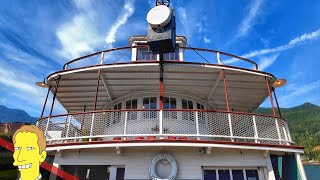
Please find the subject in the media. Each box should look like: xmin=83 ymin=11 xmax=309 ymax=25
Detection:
xmin=47 ymin=45 xmax=276 ymax=112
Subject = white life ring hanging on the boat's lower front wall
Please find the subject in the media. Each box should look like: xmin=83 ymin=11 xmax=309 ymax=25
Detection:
xmin=150 ymin=154 xmax=178 ymax=180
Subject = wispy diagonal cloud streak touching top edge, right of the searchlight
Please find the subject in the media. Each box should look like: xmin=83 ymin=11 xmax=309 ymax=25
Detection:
xmin=236 ymin=0 xmax=263 ymax=38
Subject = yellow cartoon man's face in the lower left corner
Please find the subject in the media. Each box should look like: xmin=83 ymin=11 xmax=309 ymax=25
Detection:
xmin=13 ymin=131 xmax=47 ymax=179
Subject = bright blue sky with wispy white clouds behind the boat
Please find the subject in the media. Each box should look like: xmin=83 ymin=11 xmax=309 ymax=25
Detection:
xmin=0 ymin=0 xmax=320 ymax=117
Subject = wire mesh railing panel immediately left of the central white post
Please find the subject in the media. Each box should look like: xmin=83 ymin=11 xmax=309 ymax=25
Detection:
xmin=125 ymin=111 xmax=160 ymax=135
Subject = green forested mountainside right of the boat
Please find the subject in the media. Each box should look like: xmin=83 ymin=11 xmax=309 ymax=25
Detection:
xmin=255 ymin=103 xmax=320 ymax=162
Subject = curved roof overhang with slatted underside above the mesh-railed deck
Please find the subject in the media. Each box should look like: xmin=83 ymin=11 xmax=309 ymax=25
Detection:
xmin=47 ymin=61 xmax=276 ymax=112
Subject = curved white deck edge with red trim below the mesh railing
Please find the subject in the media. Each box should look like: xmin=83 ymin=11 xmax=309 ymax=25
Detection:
xmin=46 ymin=139 xmax=304 ymax=153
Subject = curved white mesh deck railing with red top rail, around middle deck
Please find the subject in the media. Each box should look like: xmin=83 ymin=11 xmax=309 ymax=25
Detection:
xmin=37 ymin=110 xmax=293 ymax=145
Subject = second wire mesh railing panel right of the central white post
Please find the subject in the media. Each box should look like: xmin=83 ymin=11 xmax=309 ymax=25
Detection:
xmin=199 ymin=112 xmax=230 ymax=136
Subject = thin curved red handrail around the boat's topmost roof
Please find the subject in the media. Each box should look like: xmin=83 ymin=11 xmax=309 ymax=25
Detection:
xmin=63 ymin=45 xmax=258 ymax=70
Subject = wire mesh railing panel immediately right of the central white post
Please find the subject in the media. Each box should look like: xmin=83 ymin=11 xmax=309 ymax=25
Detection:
xmin=163 ymin=111 xmax=197 ymax=135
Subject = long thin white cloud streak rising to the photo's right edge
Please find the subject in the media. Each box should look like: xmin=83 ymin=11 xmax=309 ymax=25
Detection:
xmin=224 ymin=29 xmax=320 ymax=64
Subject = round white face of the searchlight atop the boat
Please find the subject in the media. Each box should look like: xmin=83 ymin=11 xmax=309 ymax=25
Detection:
xmin=147 ymin=5 xmax=171 ymax=28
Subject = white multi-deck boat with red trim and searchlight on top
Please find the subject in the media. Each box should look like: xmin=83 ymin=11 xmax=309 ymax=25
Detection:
xmin=37 ymin=1 xmax=306 ymax=180
